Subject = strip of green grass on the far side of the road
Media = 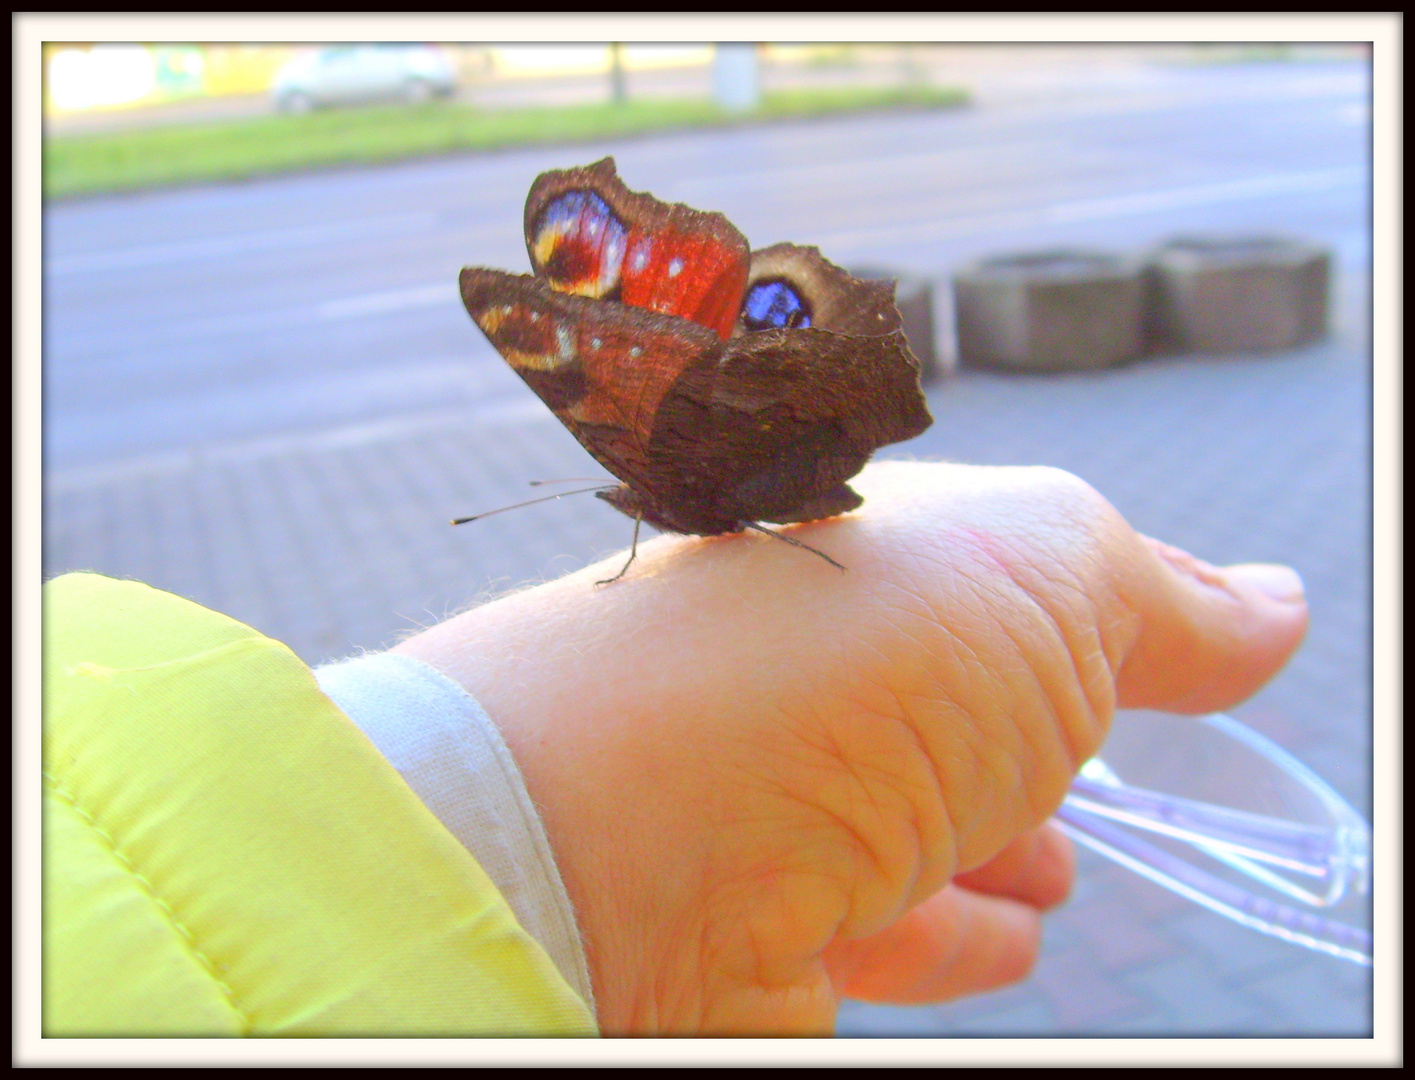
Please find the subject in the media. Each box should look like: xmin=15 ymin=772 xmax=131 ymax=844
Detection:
xmin=44 ymin=86 xmax=968 ymax=198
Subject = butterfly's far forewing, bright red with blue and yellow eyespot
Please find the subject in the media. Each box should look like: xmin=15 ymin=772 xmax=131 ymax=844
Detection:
xmin=525 ymin=157 xmax=751 ymax=337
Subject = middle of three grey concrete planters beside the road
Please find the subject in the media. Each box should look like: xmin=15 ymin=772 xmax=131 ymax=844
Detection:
xmin=954 ymin=249 xmax=1145 ymax=371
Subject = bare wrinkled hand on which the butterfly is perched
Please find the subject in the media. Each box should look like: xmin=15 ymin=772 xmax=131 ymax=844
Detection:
xmin=393 ymin=463 xmax=1307 ymax=1035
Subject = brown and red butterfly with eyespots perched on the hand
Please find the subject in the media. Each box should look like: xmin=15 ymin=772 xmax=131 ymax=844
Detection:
xmin=460 ymin=157 xmax=932 ymax=583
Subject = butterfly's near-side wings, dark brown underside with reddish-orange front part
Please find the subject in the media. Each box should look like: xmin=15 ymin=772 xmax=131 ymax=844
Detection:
xmin=461 ymin=260 xmax=931 ymax=535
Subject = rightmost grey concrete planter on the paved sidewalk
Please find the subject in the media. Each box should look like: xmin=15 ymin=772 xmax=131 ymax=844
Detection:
xmin=1146 ymin=235 xmax=1332 ymax=352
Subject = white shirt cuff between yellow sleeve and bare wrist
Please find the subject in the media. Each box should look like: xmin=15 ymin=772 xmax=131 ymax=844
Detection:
xmin=314 ymin=653 xmax=594 ymax=1013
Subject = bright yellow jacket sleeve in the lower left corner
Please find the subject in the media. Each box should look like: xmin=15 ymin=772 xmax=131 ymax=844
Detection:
xmin=42 ymin=573 xmax=596 ymax=1038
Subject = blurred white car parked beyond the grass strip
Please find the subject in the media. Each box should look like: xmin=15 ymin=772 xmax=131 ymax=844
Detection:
xmin=270 ymin=42 xmax=457 ymax=112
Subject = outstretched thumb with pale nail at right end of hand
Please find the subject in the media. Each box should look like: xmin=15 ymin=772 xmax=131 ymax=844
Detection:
xmin=1116 ymin=536 xmax=1307 ymax=713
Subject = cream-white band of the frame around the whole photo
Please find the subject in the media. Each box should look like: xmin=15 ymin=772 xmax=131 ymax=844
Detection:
xmin=11 ymin=11 xmax=1404 ymax=1066
